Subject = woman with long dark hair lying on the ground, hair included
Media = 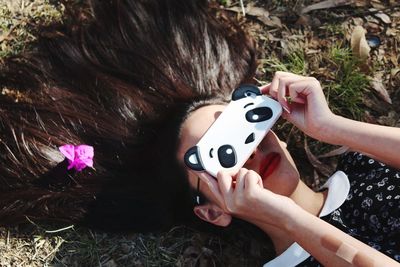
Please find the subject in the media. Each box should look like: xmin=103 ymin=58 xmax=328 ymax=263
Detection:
xmin=0 ymin=0 xmax=400 ymax=264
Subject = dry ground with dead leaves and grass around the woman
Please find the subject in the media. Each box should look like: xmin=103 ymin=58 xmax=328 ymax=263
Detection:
xmin=0 ymin=0 xmax=400 ymax=267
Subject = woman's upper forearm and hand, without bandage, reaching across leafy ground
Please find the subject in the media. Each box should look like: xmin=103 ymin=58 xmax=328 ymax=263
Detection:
xmin=261 ymin=72 xmax=400 ymax=168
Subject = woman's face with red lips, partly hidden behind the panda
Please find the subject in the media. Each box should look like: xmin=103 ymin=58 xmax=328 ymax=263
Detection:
xmin=177 ymin=105 xmax=299 ymax=205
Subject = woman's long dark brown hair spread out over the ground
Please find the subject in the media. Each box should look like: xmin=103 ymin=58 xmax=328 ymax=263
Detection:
xmin=0 ymin=0 xmax=256 ymax=231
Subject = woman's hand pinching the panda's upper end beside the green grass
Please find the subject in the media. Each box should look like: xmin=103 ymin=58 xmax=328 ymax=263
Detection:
xmin=261 ymin=72 xmax=337 ymax=141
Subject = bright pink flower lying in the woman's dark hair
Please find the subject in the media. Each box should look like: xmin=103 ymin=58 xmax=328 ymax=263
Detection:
xmin=58 ymin=145 xmax=94 ymax=172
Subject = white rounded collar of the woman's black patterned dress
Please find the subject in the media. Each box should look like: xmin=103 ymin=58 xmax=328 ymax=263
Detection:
xmin=263 ymin=171 xmax=350 ymax=267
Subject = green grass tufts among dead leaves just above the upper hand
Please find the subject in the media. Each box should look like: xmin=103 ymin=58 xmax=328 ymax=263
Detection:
xmin=260 ymin=38 xmax=370 ymax=120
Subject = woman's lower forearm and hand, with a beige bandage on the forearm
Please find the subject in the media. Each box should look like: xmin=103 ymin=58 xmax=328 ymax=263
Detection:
xmin=200 ymin=171 xmax=399 ymax=267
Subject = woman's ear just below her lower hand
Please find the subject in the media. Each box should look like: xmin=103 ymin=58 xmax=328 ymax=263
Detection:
xmin=193 ymin=203 xmax=232 ymax=227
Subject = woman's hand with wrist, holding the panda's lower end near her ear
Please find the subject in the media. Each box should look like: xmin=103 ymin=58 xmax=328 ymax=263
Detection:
xmin=200 ymin=168 xmax=299 ymax=228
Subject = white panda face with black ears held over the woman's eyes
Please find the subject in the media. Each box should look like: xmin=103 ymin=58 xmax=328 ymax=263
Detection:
xmin=184 ymin=85 xmax=282 ymax=177
